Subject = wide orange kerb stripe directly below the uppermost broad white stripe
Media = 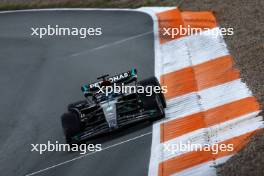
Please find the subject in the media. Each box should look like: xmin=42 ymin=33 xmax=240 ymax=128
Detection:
xmin=160 ymin=55 xmax=239 ymax=99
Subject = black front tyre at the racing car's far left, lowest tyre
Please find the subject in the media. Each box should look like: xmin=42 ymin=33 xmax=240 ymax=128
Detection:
xmin=61 ymin=112 xmax=81 ymax=144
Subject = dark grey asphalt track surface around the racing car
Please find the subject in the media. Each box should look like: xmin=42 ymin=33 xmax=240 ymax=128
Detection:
xmin=0 ymin=11 xmax=154 ymax=176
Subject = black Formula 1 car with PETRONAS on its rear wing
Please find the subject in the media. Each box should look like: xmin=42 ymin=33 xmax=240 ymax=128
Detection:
xmin=61 ymin=69 xmax=166 ymax=144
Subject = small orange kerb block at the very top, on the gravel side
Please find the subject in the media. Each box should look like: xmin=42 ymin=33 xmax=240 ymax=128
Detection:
xmin=181 ymin=11 xmax=217 ymax=29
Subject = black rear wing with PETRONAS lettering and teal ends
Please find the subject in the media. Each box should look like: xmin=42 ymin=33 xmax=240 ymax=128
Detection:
xmin=81 ymin=68 xmax=137 ymax=93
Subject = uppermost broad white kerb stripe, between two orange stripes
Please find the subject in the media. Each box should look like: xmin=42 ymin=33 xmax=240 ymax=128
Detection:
xmin=160 ymin=27 xmax=229 ymax=74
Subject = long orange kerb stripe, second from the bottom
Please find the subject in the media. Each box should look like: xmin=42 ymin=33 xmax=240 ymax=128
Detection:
xmin=160 ymin=97 xmax=260 ymax=143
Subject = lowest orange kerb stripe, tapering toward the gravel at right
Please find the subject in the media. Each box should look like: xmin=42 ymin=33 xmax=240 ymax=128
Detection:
xmin=159 ymin=130 xmax=258 ymax=176
